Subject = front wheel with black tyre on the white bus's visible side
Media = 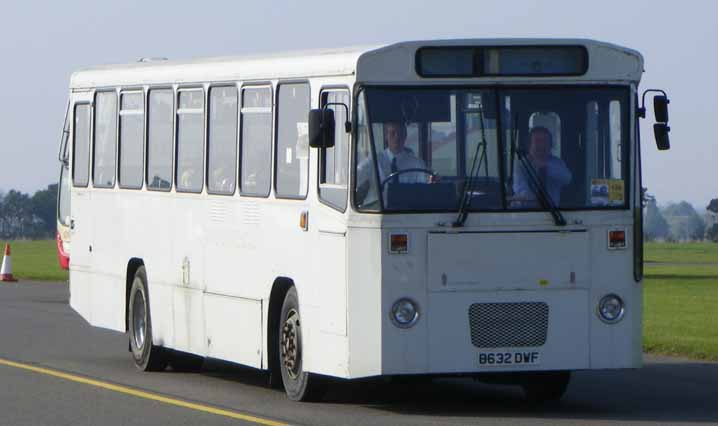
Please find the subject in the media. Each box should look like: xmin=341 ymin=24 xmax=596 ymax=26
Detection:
xmin=278 ymin=287 xmax=325 ymax=401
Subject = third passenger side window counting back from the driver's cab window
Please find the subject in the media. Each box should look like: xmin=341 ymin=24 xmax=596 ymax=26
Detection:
xmin=207 ymin=86 xmax=238 ymax=194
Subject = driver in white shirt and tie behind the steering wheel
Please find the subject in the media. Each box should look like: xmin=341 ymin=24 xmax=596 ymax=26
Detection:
xmin=377 ymin=121 xmax=431 ymax=183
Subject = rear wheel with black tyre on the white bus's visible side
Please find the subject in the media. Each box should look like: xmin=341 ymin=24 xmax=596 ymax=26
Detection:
xmin=127 ymin=266 xmax=167 ymax=371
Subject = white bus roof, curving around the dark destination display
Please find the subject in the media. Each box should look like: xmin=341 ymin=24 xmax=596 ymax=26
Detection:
xmin=70 ymin=38 xmax=643 ymax=89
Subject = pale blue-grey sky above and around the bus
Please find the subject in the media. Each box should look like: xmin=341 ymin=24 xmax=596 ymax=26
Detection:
xmin=0 ymin=0 xmax=718 ymax=211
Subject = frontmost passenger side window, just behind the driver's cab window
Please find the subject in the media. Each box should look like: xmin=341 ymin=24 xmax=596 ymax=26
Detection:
xmin=274 ymin=83 xmax=310 ymax=198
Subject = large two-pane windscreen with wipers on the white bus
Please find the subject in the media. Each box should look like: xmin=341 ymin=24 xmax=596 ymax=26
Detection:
xmin=354 ymin=87 xmax=629 ymax=211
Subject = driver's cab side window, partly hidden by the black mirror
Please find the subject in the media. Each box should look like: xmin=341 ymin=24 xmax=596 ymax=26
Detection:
xmin=319 ymin=90 xmax=349 ymax=211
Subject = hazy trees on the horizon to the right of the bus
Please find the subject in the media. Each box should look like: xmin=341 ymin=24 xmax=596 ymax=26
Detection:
xmin=643 ymin=195 xmax=718 ymax=242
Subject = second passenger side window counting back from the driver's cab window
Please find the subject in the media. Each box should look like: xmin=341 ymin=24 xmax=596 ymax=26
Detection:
xmin=239 ymin=87 xmax=272 ymax=197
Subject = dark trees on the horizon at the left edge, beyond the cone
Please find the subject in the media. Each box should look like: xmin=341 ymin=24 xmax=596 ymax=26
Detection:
xmin=0 ymin=183 xmax=57 ymax=240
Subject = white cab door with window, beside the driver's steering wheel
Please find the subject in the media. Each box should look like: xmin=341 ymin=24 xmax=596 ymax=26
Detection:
xmin=310 ymin=89 xmax=350 ymax=335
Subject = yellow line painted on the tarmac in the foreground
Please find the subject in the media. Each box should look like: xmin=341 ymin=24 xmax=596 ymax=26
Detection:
xmin=0 ymin=358 xmax=287 ymax=426
